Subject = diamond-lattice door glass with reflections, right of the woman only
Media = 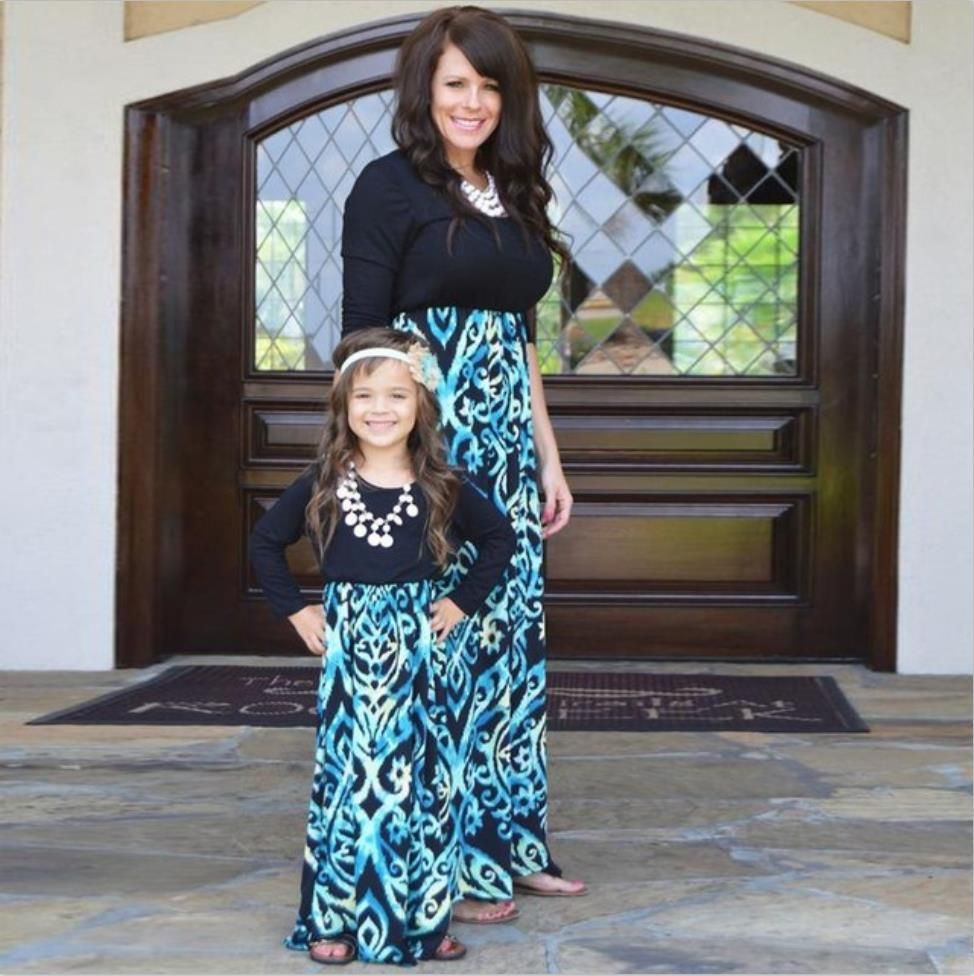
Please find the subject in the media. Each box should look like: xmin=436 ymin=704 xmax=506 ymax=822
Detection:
xmin=538 ymin=85 xmax=799 ymax=376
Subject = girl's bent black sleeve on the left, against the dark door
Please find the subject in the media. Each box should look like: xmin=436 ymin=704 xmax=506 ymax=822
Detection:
xmin=249 ymin=468 xmax=314 ymax=617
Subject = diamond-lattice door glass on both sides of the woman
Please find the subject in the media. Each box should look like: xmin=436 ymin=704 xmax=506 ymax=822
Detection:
xmin=254 ymin=85 xmax=801 ymax=377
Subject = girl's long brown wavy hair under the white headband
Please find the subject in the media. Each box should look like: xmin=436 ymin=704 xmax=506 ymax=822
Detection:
xmin=305 ymin=329 xmax=460 ymax=568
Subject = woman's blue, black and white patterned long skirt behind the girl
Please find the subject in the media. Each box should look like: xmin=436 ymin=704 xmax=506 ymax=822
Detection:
xmin=392 ymin=307 xmax=560 ymax=901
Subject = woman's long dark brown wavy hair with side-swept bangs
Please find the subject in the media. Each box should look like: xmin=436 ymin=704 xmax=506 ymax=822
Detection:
xmin=392 ymin=6 xmax=569 ymax=269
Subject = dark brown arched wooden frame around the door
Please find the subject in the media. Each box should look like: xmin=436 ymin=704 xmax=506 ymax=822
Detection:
xmin=115 ymin=11 xmax=907 ymax=671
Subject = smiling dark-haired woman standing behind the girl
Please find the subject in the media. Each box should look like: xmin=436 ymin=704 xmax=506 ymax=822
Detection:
xmin=342 ymin=7 xmax=585 ymax=924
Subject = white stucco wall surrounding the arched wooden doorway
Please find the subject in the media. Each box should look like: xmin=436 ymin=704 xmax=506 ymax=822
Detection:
xmin=0 ymin=0 xmax=974 ymax=673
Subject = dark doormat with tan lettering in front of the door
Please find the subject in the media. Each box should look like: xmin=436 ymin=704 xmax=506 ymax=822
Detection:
xmin=27 ymin=665 xmax=869 ymax=732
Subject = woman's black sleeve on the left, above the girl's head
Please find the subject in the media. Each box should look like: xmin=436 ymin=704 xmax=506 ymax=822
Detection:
xmin=342 ymin=159 xmax=413 ymax=336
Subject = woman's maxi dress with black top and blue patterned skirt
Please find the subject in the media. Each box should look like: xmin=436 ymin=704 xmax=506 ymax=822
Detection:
xmin=342 ymin=151 xmax=560 ymax=901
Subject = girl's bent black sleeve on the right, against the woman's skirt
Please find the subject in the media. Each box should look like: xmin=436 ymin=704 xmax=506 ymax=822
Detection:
xmin=449 ymin=478 xmax=517 ymax=616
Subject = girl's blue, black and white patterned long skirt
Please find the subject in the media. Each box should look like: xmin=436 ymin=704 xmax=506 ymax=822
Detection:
xmin=285 ymin=581 xmax=457 ymax=964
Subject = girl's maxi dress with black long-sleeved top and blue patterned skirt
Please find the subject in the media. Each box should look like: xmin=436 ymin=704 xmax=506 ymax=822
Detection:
xmin=250 ymin=471 xmax=515 ymax=964
